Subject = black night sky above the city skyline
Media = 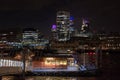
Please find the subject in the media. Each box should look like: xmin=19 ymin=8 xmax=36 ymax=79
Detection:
xmin=0 ymin=0 xmax=120 ymax=35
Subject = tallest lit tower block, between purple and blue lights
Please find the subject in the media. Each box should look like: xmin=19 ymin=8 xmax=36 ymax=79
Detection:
xmin=56 ymin=11 xmax=70 ymax=41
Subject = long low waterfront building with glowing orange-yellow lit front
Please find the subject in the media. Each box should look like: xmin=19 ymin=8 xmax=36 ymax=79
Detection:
xmin=32 ymin=53 xmax=78 ymax=71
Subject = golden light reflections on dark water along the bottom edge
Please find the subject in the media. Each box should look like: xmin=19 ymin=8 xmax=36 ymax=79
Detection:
xmin=2 ymin=76 xmax=96 ymax=80
